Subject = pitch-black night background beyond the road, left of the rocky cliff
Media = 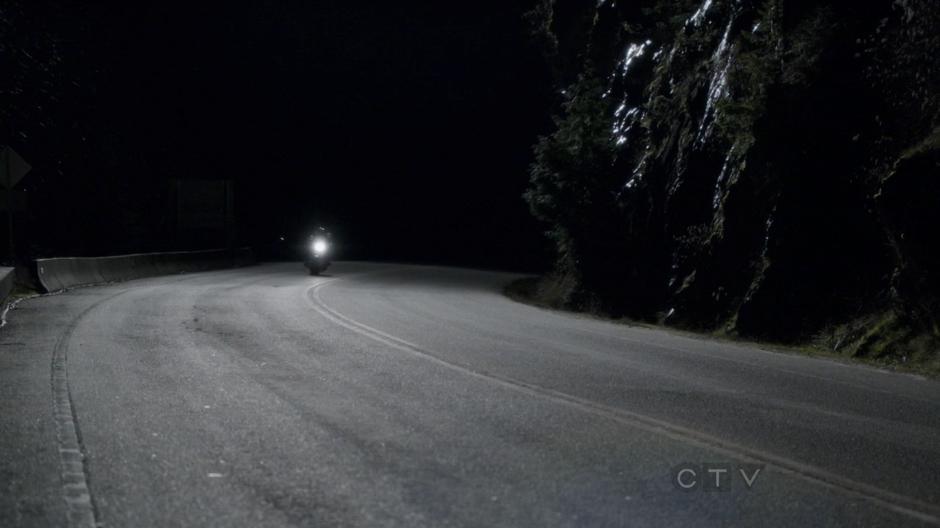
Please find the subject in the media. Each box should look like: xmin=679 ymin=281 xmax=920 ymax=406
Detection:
xmin=0 ymin=0 xmax=551 ymax=268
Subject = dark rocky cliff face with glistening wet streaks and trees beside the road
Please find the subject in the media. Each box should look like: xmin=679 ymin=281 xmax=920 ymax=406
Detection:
xmin=527 ymin=0 xmax=940 ymax=353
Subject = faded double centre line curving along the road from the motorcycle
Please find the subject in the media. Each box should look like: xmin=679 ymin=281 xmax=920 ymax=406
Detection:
xmin=305 ymin=279 xmax=940 ymax=526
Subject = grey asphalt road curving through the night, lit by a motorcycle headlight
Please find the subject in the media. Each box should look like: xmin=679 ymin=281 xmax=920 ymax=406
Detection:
xmin=0 ymin=263 xmax=940 ymax=527
